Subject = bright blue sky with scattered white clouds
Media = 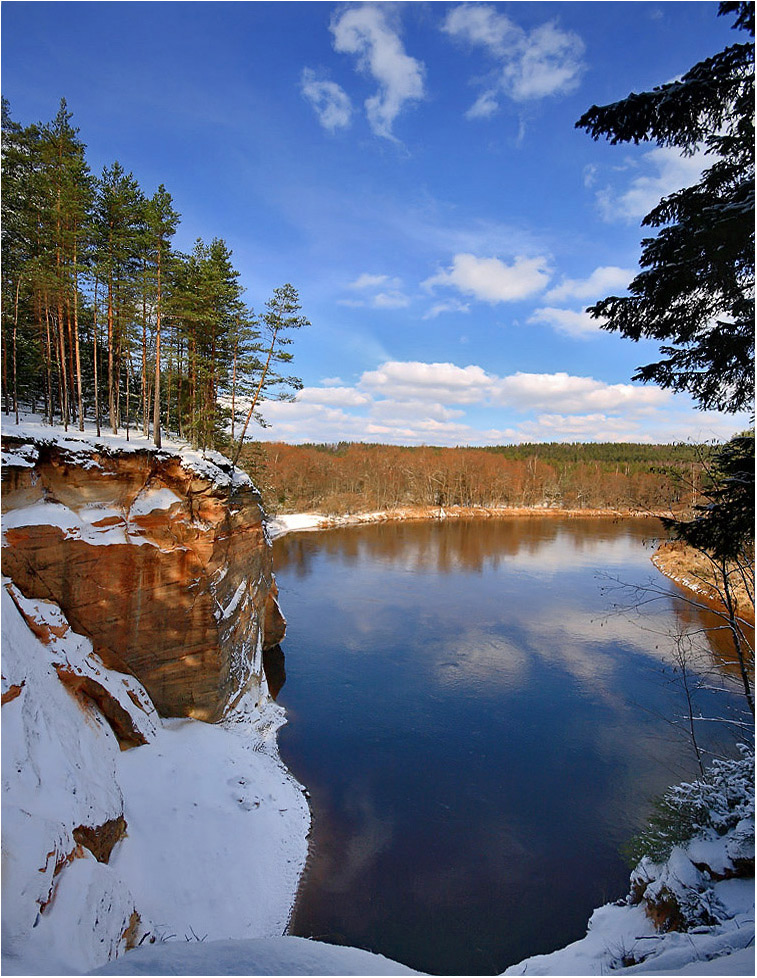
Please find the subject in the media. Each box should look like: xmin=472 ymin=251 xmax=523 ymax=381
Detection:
xmin=2 ymin=0 xmax=748 ymax=445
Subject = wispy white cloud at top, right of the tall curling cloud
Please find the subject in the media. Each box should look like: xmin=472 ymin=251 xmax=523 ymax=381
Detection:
xmin=442 ymin=3 xmax=585 ymax=119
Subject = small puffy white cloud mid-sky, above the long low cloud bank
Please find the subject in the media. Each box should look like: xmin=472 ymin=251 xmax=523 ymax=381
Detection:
xmin=423 ymin=253 xmax=551 ymax=305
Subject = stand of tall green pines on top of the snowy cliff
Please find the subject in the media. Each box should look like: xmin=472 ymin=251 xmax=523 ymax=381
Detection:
xmin=2 ymin=100 xmax=307 ymax=449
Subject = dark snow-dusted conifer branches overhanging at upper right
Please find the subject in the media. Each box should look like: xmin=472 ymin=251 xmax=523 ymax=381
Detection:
xmin=576 ymin=3 xmax=754 ymax=412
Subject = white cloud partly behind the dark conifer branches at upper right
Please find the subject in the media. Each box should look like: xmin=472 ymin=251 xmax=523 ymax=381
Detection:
xmin=597 ymin=146 xmax=706 ymax=222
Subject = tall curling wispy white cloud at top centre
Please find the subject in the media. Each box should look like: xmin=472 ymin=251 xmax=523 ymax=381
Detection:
xmin=330 ymin=3 xmax=425 ymax=139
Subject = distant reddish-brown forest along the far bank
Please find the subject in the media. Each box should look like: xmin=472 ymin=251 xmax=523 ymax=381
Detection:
xmin=250 ymin=442 xmax=709 ymax=514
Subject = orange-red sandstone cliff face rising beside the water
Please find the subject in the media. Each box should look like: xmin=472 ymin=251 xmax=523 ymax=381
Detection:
xmin=2 ymin=439 xmax=285 ymax=721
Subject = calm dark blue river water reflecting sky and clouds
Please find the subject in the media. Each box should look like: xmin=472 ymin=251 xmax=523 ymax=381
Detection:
xmin=275 ymin=518 xmax=740 ymax=975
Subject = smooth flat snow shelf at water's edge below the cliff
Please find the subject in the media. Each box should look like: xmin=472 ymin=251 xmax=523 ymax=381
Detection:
xmin=111 ymin=703 xmax=310 ymax=941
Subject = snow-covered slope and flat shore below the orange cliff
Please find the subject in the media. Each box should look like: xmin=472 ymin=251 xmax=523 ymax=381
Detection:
xmin=2 ymin=582 xmax=310 ymax=974
